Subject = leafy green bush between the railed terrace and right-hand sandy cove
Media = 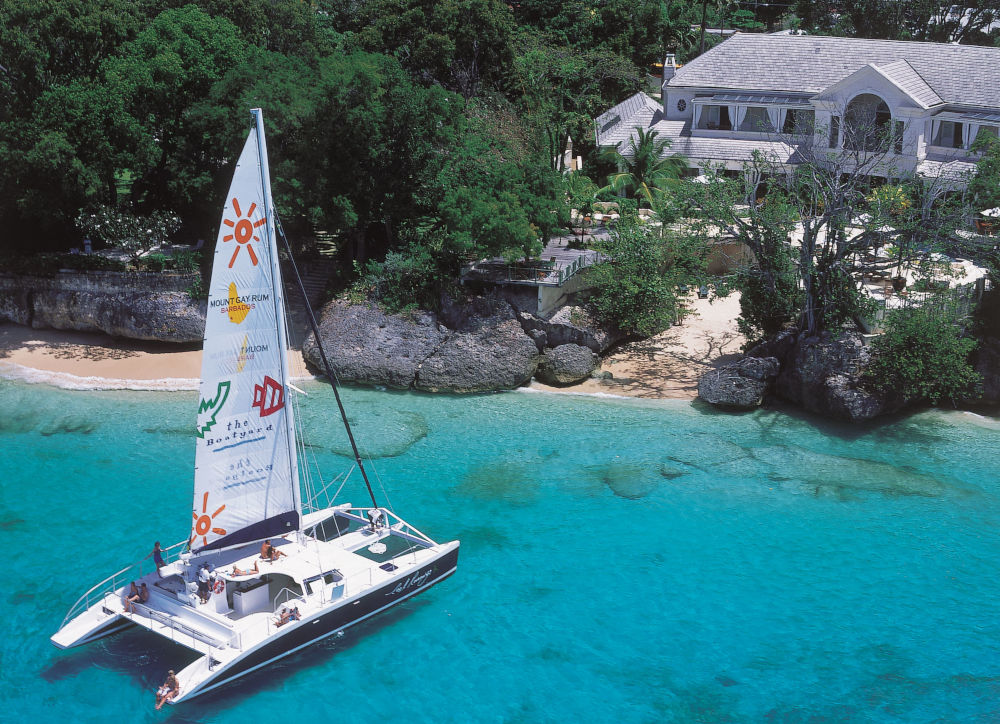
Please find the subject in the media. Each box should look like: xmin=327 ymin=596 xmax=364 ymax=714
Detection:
xmin=586 ymin=216 xmax=706 ymax=336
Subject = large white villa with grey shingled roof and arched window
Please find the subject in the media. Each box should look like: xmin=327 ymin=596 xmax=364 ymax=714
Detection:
xmin=595 ymin=33 xmax=1000 ymax=181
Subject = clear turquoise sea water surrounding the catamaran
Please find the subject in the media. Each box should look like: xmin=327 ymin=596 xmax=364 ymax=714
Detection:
xmin=0 ymin=381 xmax=1000 ymax=722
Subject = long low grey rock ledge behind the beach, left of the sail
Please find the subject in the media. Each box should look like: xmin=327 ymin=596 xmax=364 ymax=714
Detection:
xmin=0 ymin=271 xmax=206 ymax=343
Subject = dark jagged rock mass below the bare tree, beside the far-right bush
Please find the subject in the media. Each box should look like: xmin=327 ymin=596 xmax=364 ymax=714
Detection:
xmin=774 ymin=332 xmax=898 ymax=422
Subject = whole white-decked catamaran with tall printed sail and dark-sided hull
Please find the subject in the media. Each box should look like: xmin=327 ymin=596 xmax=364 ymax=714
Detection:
xmin=52 ymin=109 xmax=459 ymax=703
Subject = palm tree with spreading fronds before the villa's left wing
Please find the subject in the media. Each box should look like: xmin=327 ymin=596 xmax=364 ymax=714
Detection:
xmin=601 ymin=128 xmax=687 ymax=208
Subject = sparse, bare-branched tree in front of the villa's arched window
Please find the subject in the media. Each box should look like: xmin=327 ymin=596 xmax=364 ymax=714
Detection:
xmin=688 ymin=113 xmax=967 ymax=334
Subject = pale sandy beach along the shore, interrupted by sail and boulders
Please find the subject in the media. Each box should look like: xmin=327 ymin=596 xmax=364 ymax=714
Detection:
xmin=0 ymin=295 xmax=743 ymax=399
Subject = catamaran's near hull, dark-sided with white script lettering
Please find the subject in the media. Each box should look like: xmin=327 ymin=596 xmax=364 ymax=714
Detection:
xmin=178 ymin=541 xmax=459 ymax=703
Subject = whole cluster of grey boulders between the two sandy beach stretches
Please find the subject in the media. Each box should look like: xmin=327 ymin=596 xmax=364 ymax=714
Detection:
xmin=302 ymin=296 xmax=623 ymax=393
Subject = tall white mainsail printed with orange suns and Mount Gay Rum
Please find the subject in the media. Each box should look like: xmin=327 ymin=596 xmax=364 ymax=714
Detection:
xmin=191 ymin=110 xmax=299 ymax=551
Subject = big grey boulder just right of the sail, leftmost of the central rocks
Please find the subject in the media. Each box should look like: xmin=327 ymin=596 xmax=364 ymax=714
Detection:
xmin=302 ymin=300 xmax=447 ymax=389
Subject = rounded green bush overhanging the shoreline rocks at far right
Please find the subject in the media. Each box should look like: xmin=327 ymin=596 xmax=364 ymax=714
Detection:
xmin=864 ymin=305 xmax=980 ymax=405
